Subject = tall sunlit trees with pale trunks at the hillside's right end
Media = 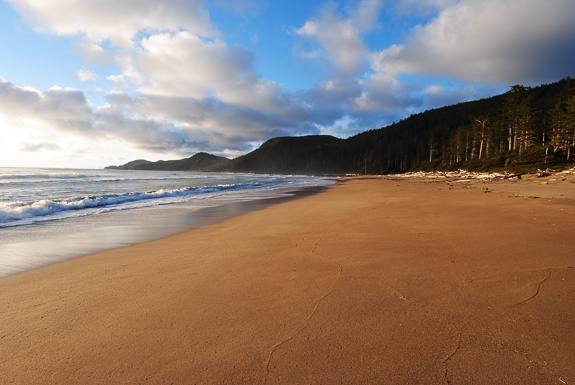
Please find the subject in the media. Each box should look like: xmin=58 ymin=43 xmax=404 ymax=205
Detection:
xmin=438 ymin=78 xmax=575 ymax=165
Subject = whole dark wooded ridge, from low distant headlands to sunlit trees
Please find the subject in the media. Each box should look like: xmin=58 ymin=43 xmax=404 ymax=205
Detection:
xmin=110 ymin=77 xmax=575 ymax=174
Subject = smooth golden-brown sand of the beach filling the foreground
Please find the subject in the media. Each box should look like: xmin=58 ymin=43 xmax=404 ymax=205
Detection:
xmin=0 ymin=178 xmax=575 ymax=385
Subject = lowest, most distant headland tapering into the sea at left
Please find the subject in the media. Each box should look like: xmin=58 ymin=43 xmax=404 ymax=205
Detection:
xmin=106 ymin=152 xmax=230 ymax=171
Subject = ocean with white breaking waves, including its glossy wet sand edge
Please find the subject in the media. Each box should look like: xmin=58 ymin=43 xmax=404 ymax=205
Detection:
xmin=0 ymin=168 xmax=335 ymax=277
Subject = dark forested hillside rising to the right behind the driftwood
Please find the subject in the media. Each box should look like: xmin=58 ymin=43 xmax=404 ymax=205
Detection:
xmin=349 ymin=77 xmax=575 ymax=174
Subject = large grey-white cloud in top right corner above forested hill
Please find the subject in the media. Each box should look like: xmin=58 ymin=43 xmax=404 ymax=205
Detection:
xmin=373 ymin=0 xmax=575 ymax=84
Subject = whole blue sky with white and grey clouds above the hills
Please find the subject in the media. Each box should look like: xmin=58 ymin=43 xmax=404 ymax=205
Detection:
xmin=0 ymin=0 xmax=575 ymax=168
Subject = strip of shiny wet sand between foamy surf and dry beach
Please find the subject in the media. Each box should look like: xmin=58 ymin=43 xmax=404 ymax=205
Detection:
xmin=0 ymin=186 xmax=325 ymax=280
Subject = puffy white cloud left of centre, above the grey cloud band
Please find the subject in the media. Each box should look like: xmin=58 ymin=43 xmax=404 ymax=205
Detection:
xmin=132 ymin=31 xmax=302 ymax=114
